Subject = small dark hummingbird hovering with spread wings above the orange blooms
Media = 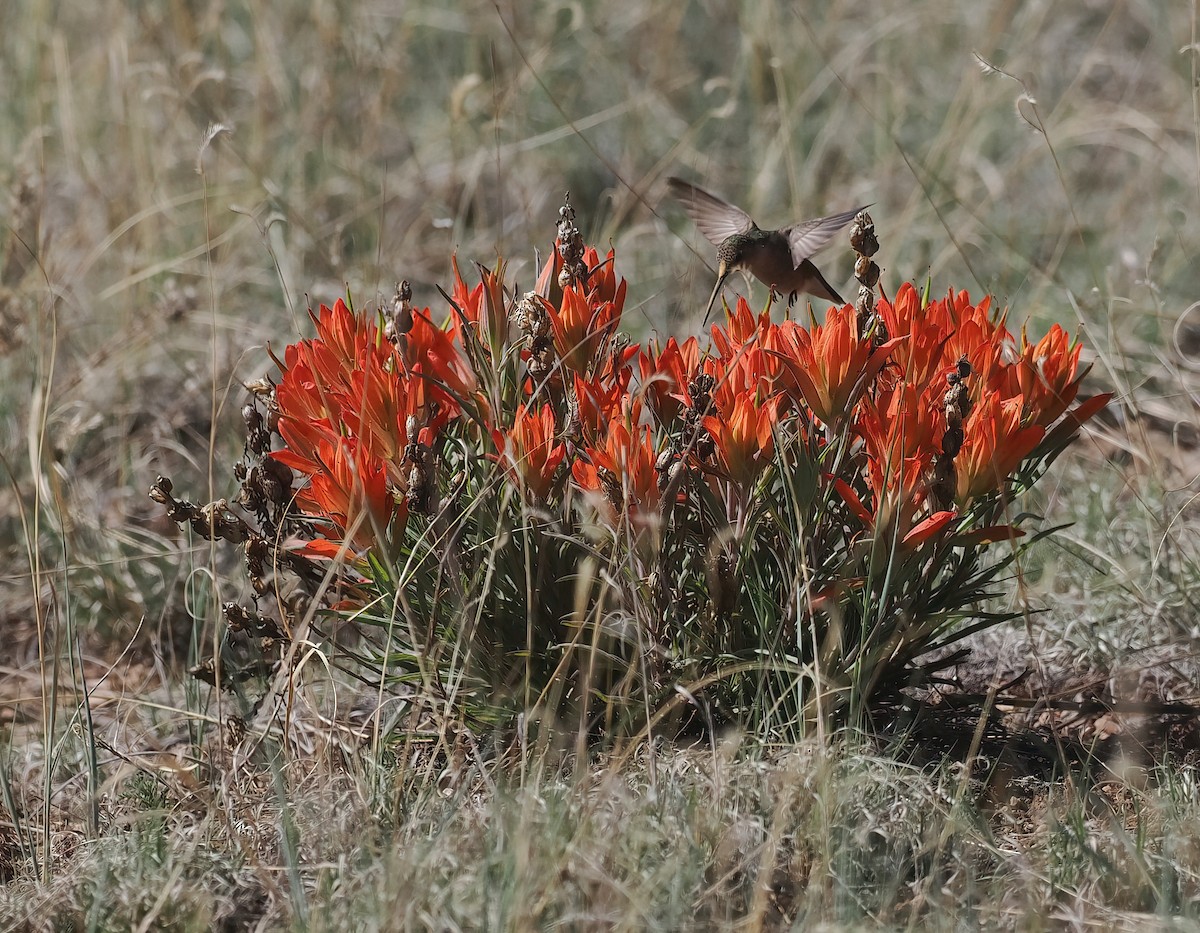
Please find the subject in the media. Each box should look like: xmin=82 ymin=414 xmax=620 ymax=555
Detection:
xmin=667 ymin=177 xmax=863 ymax=323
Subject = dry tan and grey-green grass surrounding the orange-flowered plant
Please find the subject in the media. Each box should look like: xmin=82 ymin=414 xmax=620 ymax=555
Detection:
xmin=0 ymin=0 xmax=1200 ymax=929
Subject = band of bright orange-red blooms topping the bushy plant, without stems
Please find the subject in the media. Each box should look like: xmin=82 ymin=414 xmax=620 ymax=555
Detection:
xmin=275 ymin=249 xmax=1106 ymax=549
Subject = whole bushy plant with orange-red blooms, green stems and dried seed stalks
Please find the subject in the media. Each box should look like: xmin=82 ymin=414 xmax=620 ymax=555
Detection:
xmin=155 ymin=193 xmax=1108 ymax=736
